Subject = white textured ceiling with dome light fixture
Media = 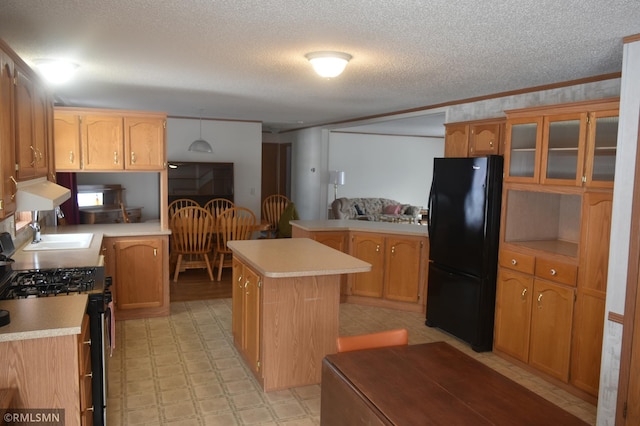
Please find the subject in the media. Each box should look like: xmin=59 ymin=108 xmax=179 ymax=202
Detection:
xmin=0 ymin=0 xmax=640 ymax=132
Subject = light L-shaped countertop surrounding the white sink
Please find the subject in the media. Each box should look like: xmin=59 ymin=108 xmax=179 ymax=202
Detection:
xmin=12 ymin=222 xmax=171 ymax=271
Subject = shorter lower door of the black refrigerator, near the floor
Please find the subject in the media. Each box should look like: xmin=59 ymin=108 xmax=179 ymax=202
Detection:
xmin=426 ymin=262 xmax=495 ymax=352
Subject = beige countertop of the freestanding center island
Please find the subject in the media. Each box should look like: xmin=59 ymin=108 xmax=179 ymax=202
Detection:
xmin=227 ymin=238 xmax=371 ymax=278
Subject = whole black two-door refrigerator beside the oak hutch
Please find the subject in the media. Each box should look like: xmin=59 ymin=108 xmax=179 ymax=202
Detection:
xmin=426 ymin=155 xmax=503 ymax=352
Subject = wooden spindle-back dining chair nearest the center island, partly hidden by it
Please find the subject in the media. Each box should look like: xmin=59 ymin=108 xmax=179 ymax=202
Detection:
xmin=216 ymin=207 xmax=256 ymax=281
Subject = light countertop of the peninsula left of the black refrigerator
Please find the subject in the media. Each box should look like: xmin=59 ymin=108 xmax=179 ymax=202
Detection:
xmin=290 ymin=219 xmax=429 ymax=237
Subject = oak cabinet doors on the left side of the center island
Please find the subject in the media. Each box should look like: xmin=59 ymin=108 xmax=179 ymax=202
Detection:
xmin=231 ymin=258 xmax=261 ymax=375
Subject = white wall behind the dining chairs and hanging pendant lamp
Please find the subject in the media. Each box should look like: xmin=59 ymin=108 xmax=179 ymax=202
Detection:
xmin=167 ymin=118 xmax=262 ymax=218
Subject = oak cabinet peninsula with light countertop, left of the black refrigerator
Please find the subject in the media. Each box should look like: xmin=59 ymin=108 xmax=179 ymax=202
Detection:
xmin=291 ymin=219 xmax=429 ymax=312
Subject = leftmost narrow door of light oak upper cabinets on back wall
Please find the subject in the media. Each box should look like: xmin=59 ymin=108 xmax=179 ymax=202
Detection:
xmin=53 ymin=112 xmax=81 ymax=170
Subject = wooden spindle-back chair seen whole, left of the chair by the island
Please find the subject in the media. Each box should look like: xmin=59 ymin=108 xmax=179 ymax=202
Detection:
xmin=170 ymin=206 xmax=214 ymax=282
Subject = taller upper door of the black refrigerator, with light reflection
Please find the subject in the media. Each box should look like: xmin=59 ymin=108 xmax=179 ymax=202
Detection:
xmin=429 ymin=157 xmax=488 ymax=277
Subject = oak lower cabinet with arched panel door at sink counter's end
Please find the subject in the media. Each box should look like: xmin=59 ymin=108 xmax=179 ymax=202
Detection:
xmin=103 ymin=235 xmax=169 ymax=319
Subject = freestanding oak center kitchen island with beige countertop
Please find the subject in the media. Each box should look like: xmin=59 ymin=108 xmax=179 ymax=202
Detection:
xmin=228 ymin=238 xmax=371 ymax=391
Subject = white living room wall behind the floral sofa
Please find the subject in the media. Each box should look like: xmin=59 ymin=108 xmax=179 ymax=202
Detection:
xmin=325 ymin=132 xmax=444 ymax=207
